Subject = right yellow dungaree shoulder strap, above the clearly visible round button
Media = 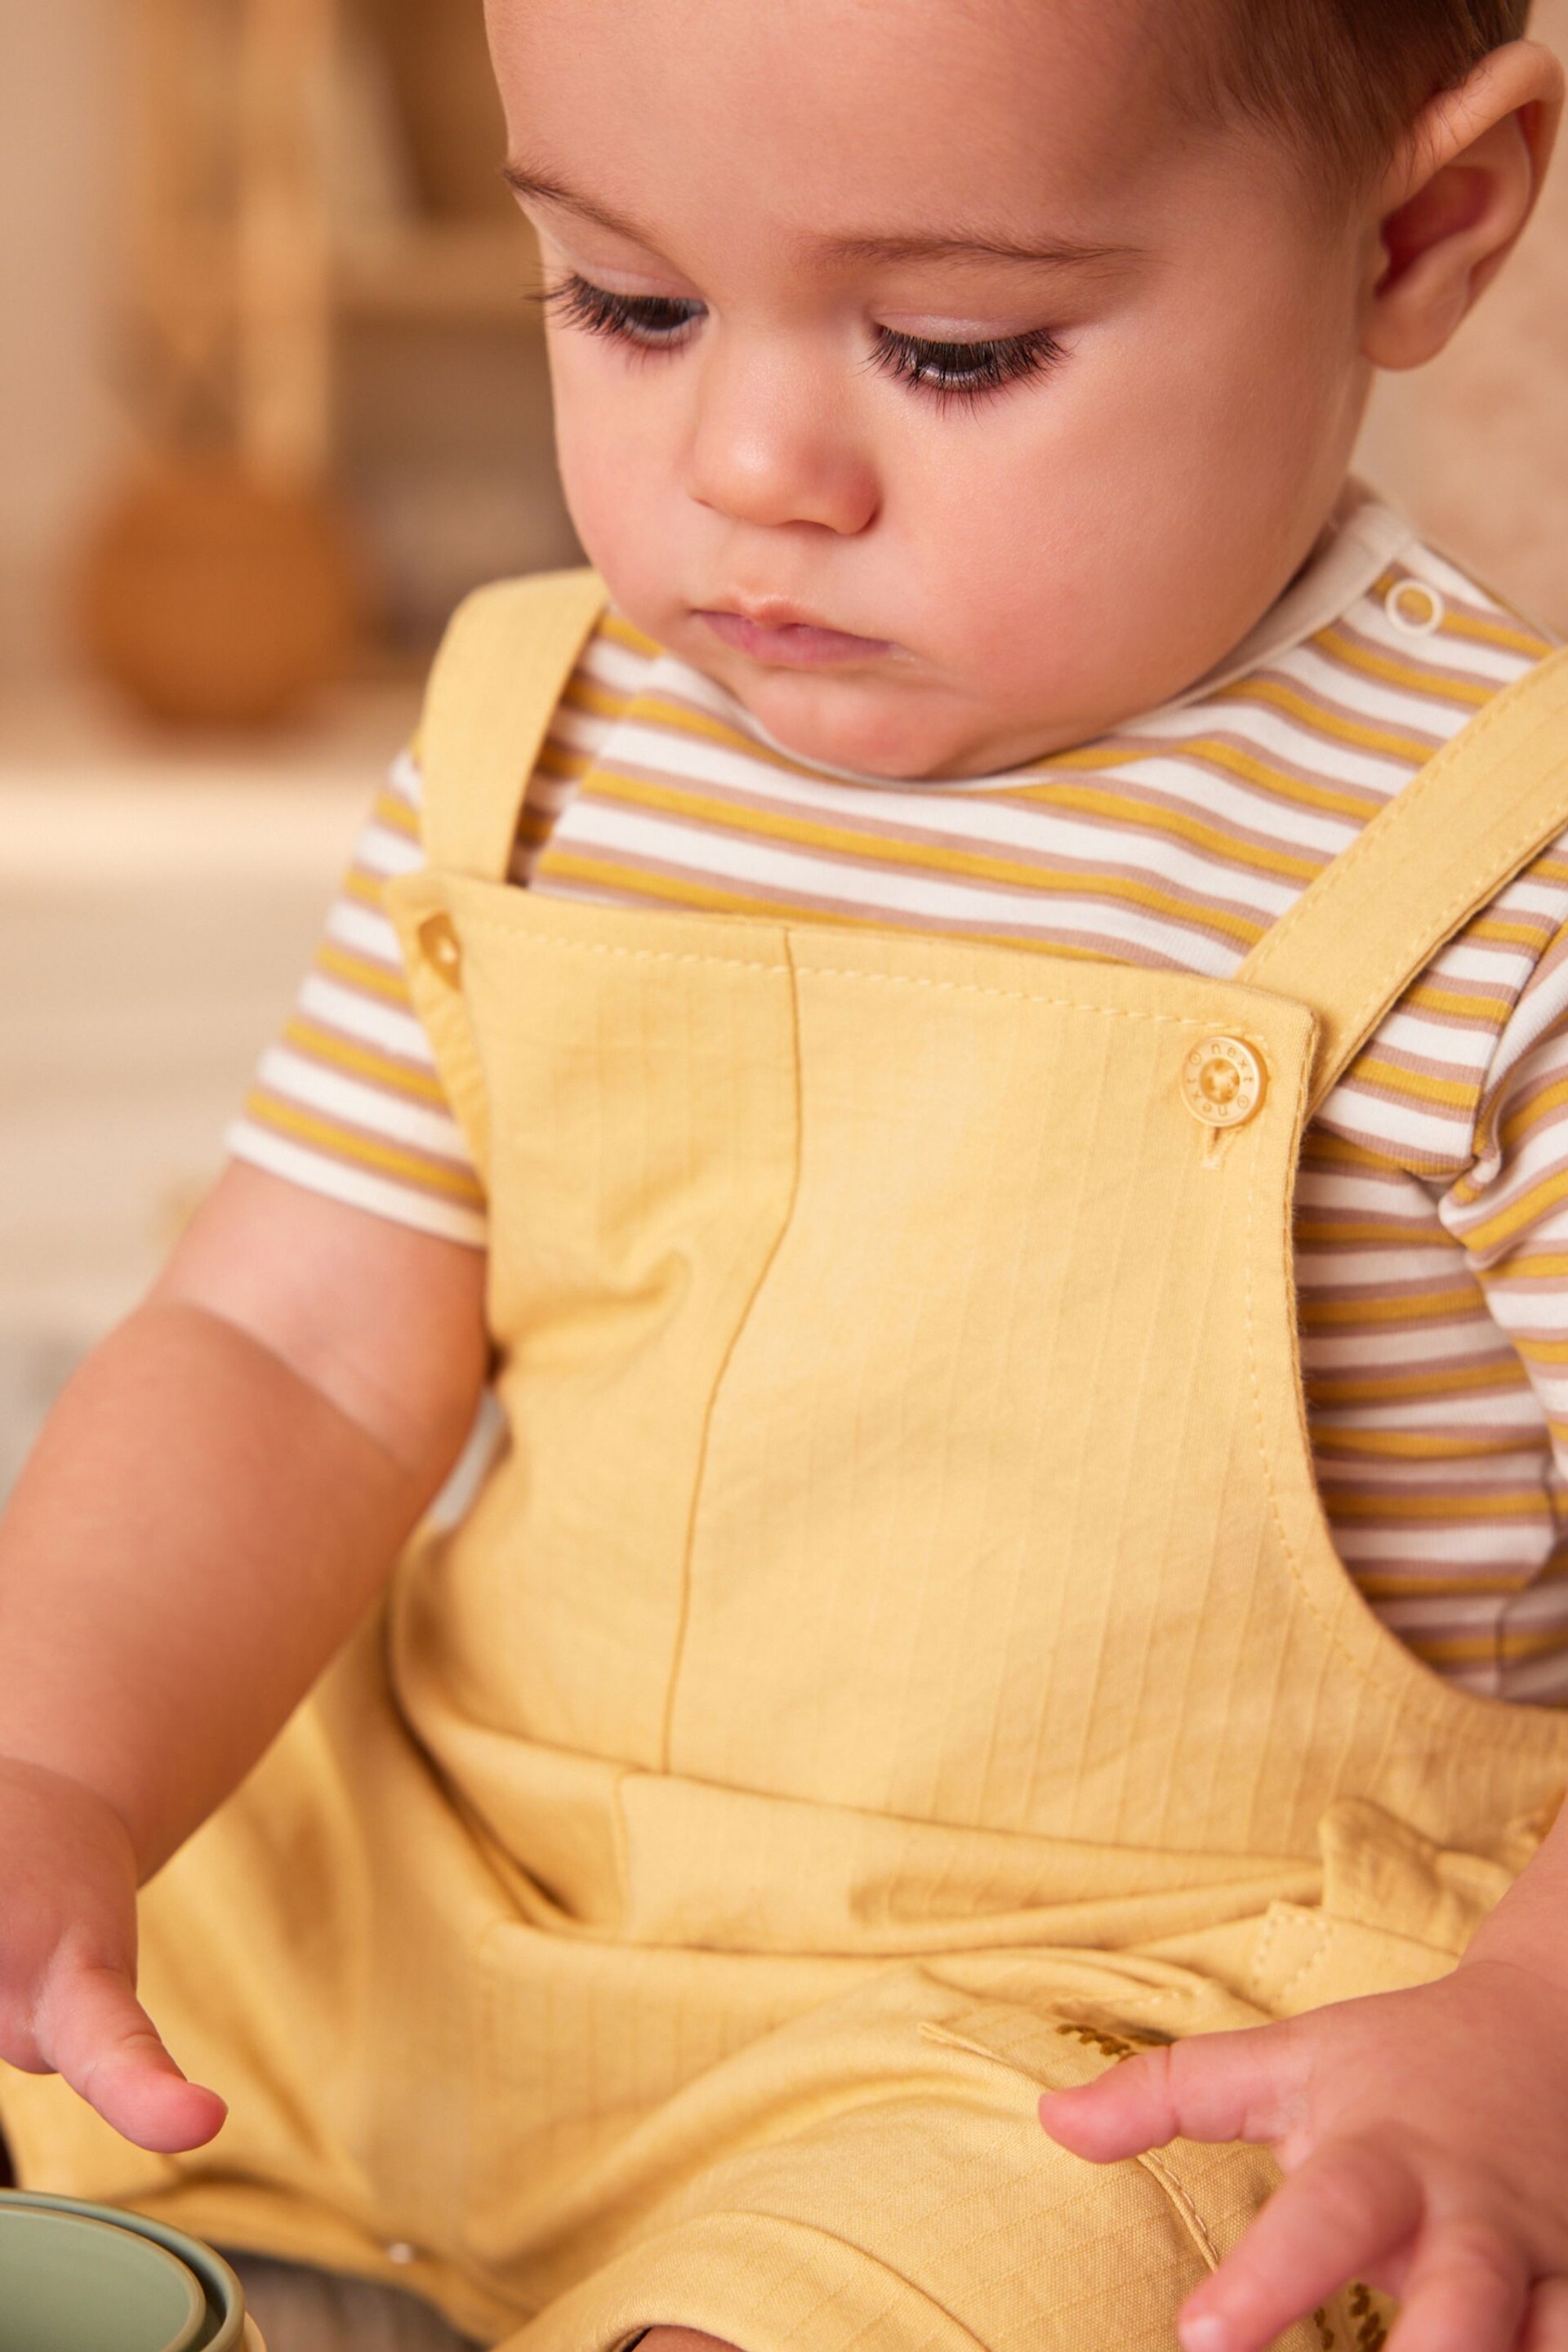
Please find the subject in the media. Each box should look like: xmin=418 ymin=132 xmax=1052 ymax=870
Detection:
xmin=1236 ymin=649 xmax=1568 ymax=1110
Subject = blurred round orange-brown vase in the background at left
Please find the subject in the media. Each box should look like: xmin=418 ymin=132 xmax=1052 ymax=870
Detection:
xmin=80 ymin=459 xmax=362 ymax=727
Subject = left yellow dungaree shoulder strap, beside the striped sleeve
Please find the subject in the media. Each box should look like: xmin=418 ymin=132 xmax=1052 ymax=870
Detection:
xmin=418 ymin=572 xmax=607 ymax=882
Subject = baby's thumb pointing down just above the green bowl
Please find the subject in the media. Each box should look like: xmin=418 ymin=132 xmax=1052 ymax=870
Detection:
xmin=38 ymin=1962 xmax=228 ymax=2154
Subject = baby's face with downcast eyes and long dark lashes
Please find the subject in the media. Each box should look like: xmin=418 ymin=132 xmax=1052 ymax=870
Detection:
xmin=492 ymin=0 xmax=1368 ymax=776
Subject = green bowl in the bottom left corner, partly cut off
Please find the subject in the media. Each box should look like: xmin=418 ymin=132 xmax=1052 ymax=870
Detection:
xmin=0 ymin=2189 xmax=259 ymax=2352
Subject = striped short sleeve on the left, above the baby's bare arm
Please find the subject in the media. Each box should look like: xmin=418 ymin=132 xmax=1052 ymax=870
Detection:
xmin=225 ymin=753 xmax=487 ymax=1249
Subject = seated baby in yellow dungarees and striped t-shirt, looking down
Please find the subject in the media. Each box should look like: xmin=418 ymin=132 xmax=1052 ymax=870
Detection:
xmin=0 ymin=0 xmax=1568 ymax=2352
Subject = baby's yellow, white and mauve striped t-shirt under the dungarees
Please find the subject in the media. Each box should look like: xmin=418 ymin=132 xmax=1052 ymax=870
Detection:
xmin=230 ymin=501 xmax=1568 ymax=1703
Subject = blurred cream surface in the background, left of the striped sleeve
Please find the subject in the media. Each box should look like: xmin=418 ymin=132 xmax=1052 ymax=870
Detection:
xmin=0 ymin=692 xmax=412 ymax=1491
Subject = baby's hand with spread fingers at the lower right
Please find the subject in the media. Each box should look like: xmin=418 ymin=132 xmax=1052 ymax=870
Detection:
xmin=1039 ymin=1959 xmax=1568 ymax=2352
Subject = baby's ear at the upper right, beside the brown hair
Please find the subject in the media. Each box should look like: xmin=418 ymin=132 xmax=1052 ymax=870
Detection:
xmin=1361 ymin=40 xmax=1563 ymax=367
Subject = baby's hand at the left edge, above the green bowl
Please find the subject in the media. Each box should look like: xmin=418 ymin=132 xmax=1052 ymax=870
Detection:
xmin=0 ymin=1759 xmax=225 ymax=2154
